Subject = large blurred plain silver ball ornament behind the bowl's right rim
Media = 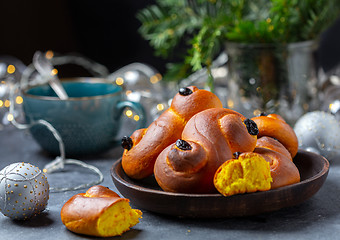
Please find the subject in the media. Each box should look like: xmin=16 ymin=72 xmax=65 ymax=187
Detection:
xmin=294 ymin=111 xmax=340 ymax=160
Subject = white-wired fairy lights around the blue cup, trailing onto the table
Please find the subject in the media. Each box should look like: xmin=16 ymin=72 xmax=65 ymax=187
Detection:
xmin=0 ymin=51 xmax=174 ymax=192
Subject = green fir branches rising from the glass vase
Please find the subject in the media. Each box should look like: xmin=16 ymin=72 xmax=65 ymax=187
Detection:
xmin=137 ymin=0 xmax=340 ymax=80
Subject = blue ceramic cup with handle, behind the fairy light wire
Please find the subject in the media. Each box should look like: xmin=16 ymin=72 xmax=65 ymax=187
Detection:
xmin=23 ymin=78 xmax=145 ymax=156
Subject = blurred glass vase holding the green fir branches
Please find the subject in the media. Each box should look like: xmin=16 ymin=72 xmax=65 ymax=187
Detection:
xmin=226 ymin=41 xmax=318 ymax=124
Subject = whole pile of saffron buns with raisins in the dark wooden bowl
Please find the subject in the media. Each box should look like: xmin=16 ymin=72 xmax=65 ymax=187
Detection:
xmin=122 ymin=86 xmax=300 ymax=196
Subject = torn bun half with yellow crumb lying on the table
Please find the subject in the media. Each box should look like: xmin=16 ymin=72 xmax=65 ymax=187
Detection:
xmin=61 ymin=185 xmax=142 ymax=237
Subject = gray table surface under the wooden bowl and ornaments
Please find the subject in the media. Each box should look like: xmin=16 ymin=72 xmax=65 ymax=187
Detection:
xmin=0 ymin=126 xmax=340 ymax=240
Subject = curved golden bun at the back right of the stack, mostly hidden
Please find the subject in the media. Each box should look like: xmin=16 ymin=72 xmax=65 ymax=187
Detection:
xmin=252 ymin=114 xmax=299 ymax=158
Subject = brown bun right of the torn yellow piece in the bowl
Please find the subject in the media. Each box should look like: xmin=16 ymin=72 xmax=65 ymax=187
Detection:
xmin=254 ymin=137 xmax=300 ymax=189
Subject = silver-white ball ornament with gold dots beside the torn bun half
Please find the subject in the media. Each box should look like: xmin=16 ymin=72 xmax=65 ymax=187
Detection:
xmin=0 ymin=163 xmax=49 ymax=220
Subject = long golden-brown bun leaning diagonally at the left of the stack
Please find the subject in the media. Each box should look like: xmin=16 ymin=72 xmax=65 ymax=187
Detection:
xmin=122 ymin=86 xmax=222 ymax=179
